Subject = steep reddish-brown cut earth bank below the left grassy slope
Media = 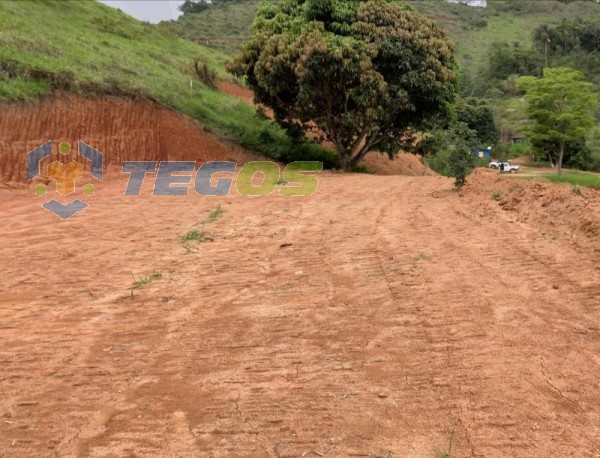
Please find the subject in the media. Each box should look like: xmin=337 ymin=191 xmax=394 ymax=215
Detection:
xmin=0 ymin=95 xmax=259 ymax=182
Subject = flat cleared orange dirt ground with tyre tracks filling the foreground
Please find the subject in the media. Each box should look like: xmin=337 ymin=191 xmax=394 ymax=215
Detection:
xmin=0 ymin=174 xmax=600 ymax=457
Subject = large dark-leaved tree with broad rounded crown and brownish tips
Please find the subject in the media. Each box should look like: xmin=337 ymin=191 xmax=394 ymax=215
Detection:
xmin=229 ymin=0 xmax=456 ymax=171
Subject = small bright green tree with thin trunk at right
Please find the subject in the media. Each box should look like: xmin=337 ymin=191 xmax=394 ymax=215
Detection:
xmin=519 ymin=67 xmax=597 ymax=176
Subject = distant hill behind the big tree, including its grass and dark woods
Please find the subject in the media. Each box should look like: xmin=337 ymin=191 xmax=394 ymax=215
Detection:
xmin=175 ymin=0 xmax=600 ymax=139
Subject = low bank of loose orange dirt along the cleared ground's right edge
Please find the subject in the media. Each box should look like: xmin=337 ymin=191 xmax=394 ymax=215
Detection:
xmin=466 ymin=169 xmax=600 ymax=252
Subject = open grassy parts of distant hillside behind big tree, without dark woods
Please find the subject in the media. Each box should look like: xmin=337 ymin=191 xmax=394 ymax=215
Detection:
xmin=175 ymin=0 xmax=600 ymax=140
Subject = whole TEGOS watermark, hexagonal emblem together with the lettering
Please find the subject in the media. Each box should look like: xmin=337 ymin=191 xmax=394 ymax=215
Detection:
xmin=27 ymin=140 xmax=323 ymax=219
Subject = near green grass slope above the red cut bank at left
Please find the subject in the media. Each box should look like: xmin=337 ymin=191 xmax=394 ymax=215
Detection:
xmin=0 ymin=0 xmax=333 ymax=166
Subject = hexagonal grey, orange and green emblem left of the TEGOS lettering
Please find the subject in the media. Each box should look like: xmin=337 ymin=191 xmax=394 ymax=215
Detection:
xmin=27 ymin=140 xmax=104 ymax=219
